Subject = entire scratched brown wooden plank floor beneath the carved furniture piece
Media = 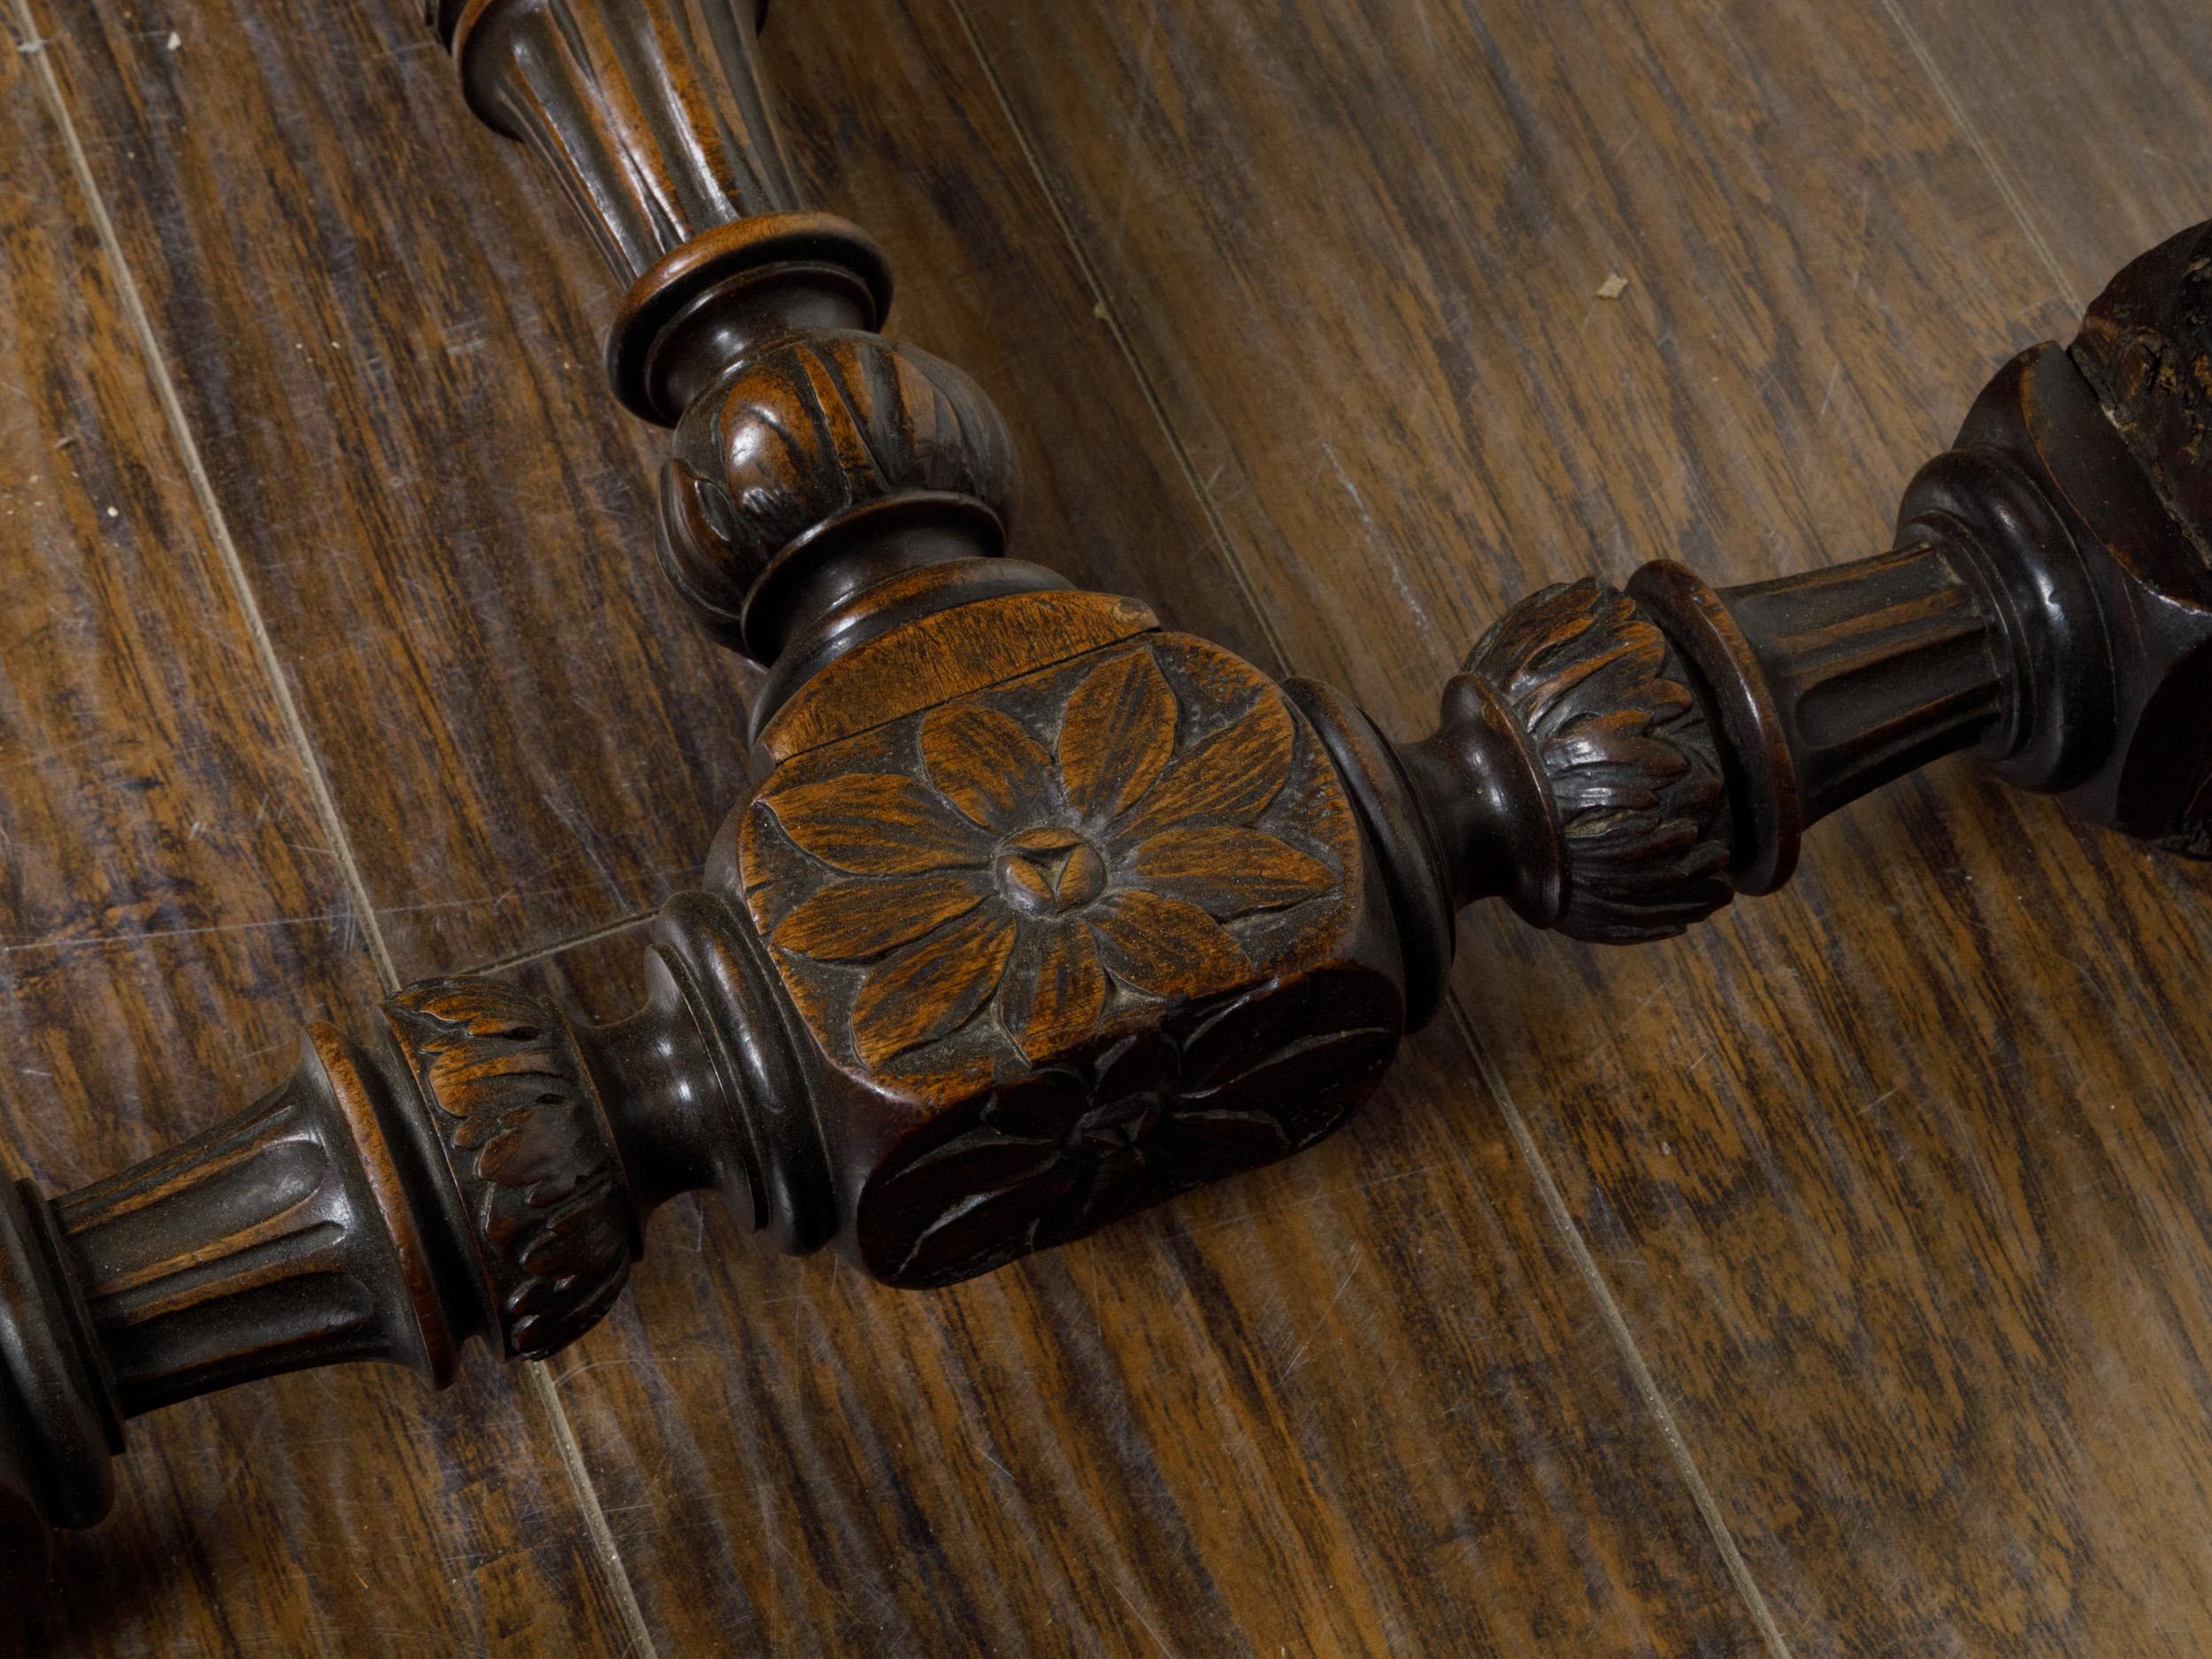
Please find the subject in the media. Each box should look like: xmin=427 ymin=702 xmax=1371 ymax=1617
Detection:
xmin=0 ymin=0 xmax=2212 ymax=1659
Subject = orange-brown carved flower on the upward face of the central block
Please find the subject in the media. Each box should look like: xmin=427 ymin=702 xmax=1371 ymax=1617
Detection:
xmin=746 ymin=640 xmax=1349 ymax=1093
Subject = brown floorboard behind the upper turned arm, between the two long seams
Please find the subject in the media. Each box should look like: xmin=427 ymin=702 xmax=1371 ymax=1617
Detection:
xmin=34 ymin=0 xmax=1283 ymax=980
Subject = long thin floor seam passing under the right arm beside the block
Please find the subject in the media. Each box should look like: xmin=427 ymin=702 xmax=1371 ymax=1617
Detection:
xmin=947 ymin=0 xmax=1796 ymax=1659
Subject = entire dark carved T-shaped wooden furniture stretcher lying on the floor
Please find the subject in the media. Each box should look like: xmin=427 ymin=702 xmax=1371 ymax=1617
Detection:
xmin=0 ymin=0 xmax=2212 ymax=1571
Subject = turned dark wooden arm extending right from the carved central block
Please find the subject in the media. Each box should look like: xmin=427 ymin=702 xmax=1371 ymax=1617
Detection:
xmin=1292 ymin=226 xmax=2212 ymax=1026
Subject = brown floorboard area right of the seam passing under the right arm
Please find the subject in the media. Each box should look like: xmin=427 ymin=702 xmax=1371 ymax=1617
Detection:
xmin=972 ymin=0 xmax=2212 ymax=1653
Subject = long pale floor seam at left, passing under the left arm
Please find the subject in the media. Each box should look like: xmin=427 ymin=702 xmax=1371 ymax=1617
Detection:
xmin=13 ymin=16 xmax=655 ymax=1659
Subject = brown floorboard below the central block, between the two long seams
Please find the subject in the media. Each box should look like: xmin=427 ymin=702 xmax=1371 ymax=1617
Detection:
xmin=525 ymin=925 xmax=1759 ymax=1659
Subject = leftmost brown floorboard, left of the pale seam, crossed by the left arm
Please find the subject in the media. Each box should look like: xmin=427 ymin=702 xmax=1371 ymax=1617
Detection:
xmin=0 ymin=26 xmax=622 ymax=1657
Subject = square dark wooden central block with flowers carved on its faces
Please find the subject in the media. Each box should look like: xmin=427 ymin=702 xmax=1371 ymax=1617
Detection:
xmin=739 ymin=635 xmax=1402 ymax=1286
